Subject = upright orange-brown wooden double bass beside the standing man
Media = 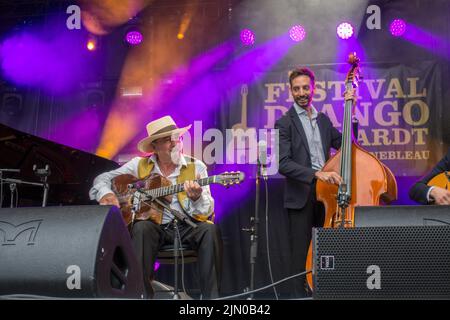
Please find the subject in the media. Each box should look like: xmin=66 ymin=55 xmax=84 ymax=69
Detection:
xmin=306 ymin=52 xmax=397 ymax=290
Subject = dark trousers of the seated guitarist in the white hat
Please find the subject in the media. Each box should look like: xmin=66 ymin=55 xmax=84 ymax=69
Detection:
xmin=131 ymin=220 xmax=222 ymax=299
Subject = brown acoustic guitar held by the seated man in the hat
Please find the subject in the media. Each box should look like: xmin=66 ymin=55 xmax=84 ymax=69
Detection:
xmin=111 ymin=171 xmax=244 ymax=226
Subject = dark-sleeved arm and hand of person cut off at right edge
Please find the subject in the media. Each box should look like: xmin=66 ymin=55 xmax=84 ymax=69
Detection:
xmin=409 ymin=148 xmax=450 ymax=205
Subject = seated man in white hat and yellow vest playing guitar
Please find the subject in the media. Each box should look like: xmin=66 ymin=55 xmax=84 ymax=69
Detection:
xmin=89 ymin=116 xmax=222 ymax=299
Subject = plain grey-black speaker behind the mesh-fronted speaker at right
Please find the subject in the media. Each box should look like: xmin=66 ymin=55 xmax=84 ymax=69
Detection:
xmin=355 ymin=205 xmax=450 ymax=227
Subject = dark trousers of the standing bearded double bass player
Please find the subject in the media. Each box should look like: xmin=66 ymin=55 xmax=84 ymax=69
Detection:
xmin=287 ymin=185 xmax=325 ymax=298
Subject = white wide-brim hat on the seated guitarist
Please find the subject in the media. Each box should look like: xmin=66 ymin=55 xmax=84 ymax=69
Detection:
xmin=137 ymin=116 xmax=192 ymax=153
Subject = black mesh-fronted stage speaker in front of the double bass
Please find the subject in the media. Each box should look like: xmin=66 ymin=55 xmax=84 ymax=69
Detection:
xmin=313 ymin=226 xmax=450 ymax=299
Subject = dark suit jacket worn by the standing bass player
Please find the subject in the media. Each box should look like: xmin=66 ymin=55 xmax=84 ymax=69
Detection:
xmin=275 ymin=106 xmax=341 ymax=209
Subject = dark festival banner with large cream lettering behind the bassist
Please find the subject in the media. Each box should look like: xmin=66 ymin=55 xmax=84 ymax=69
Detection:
xmin=227 ymin=61 xmax=444 ymax=176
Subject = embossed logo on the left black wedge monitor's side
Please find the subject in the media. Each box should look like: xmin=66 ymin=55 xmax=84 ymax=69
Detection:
xmin=0 ymin=220 xmax=42 ymax=246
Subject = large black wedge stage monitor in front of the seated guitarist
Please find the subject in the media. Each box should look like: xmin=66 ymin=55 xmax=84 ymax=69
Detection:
xmin=0 ymin=205 xmax=144 ymax=298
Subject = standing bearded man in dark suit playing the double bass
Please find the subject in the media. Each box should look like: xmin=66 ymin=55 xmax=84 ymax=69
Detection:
xmin=275 ymin=68 xmax=356 ymax=298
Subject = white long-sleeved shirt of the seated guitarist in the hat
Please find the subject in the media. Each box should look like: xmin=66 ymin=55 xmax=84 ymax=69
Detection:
xmin=89 ymin=155 xmax=214 ymax=224
